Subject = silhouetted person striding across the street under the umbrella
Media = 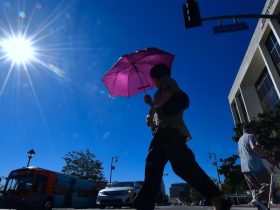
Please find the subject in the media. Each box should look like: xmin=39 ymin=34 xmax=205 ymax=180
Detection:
xmin=134 ymin=64 xmax=231 ymax=210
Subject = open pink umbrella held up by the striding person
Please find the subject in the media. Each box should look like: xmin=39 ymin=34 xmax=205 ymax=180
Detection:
xmin=102 ymin=48 xmax=174 ymax=96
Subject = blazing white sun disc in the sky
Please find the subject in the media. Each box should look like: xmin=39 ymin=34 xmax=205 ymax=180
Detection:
xmin=0 ymin=36 xmax=35 ymax=65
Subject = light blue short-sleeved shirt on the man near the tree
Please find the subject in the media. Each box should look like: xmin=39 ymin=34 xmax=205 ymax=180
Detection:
xmin=238 ymin=132 xmax=266 ymax=173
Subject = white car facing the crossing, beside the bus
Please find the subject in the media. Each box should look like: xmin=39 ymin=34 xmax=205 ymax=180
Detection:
xmin=96 ymin=181 xmax=143 ymax=209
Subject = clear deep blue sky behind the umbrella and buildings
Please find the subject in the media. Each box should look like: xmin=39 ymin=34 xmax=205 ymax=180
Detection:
xmin=0 ymin=0 xmax=265 ymax=193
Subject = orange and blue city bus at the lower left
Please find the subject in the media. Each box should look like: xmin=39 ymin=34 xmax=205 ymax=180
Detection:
xmin=1 ymin=167 xmax=99 ymax=210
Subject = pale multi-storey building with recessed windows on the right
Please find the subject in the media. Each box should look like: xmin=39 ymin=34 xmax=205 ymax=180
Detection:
xmin=228 ymin=0 xmax=280 ymax=125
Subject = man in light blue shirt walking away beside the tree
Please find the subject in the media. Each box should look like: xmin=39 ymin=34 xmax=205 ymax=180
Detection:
xmin=238 ymin=123 xmax=270 ymax=210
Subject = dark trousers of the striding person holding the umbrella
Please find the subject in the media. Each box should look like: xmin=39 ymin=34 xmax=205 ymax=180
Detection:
xmin=134 ymin=128 xmax=221 ymax=210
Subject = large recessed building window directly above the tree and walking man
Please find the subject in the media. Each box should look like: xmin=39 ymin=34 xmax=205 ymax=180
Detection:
xmin=255 ymin=69 xmax=279 ymax=113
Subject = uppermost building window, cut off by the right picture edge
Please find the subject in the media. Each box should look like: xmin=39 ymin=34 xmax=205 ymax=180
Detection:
xmin=265 ymin=31 xmax=280 ymax=74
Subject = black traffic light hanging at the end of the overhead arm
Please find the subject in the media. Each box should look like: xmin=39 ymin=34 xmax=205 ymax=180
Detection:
xmin=183 ymin=0 xmax=202 ymax=28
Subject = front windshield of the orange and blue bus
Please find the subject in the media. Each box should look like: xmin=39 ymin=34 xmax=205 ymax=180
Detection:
xmin=5 ymin=174 xmax=33 ymax=192
